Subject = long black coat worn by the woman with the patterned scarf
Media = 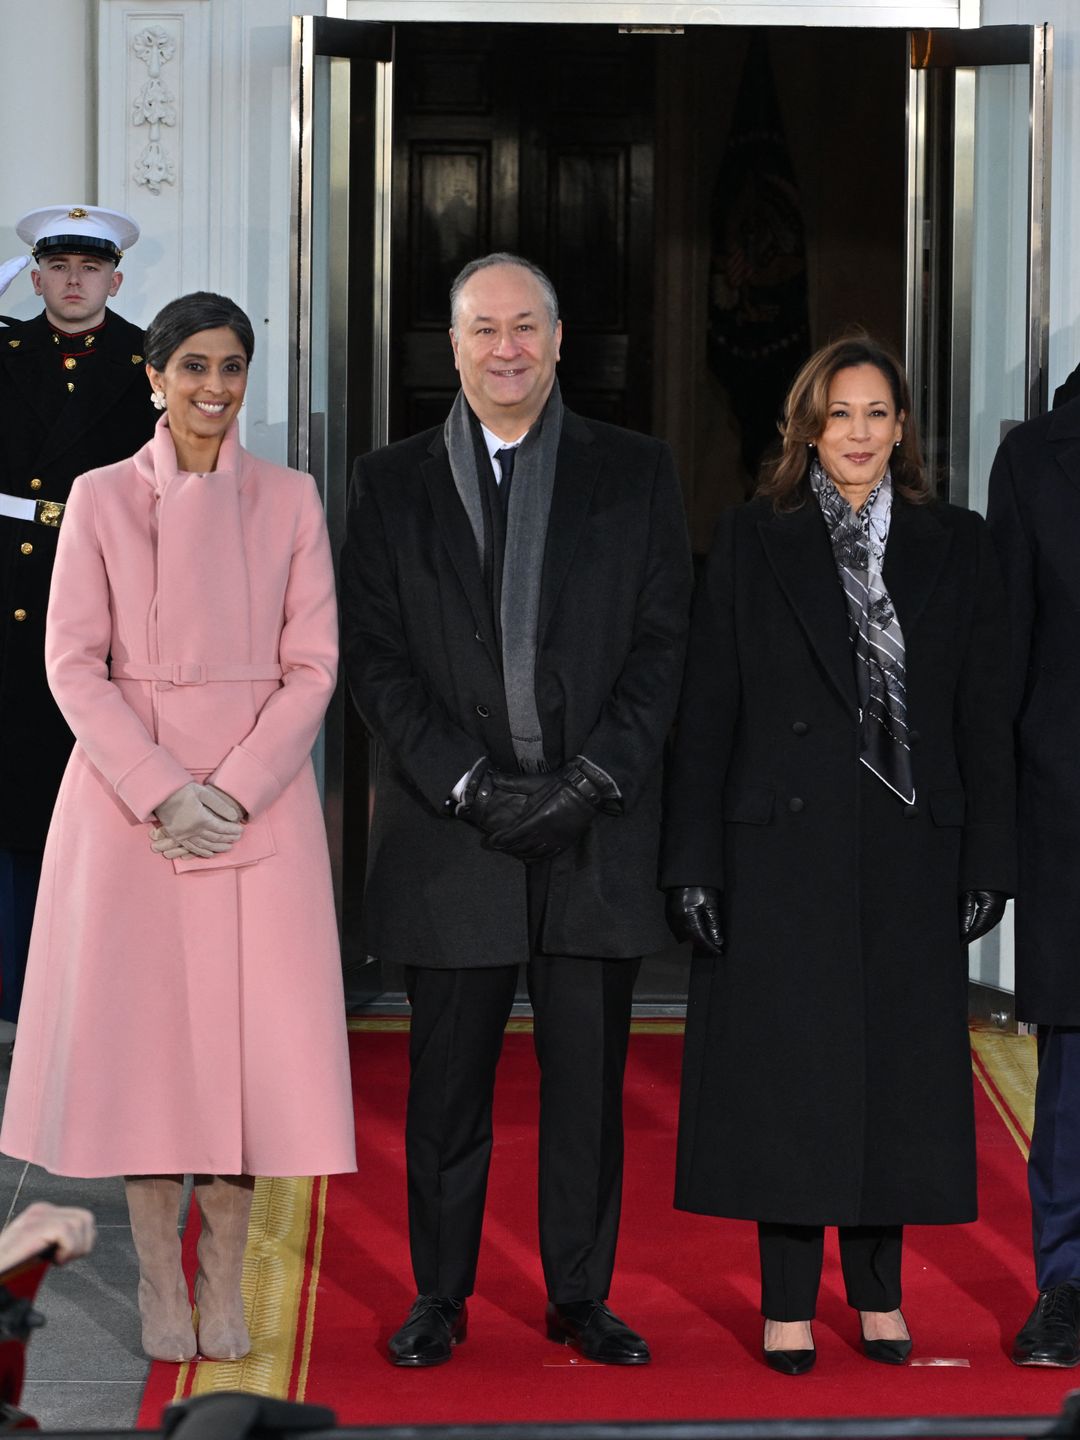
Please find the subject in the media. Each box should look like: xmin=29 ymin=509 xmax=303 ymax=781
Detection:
xmin=664 ymin=497 xmax=1015 ymax=1224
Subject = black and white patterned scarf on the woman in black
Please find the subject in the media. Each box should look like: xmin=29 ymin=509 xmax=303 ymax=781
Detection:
xmin=809 ymin=459 xmax=914 ymax=805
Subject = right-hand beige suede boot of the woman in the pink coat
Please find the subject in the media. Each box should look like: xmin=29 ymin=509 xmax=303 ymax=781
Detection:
xmin=194 ymin=1175 xmax=255 ymax=1359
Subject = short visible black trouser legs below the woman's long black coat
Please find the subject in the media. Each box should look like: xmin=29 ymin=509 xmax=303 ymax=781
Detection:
xmin=757 ymin=1223 xmax=904 ymax=1320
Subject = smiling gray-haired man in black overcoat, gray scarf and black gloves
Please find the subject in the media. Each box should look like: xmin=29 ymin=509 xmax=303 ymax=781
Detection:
xmin=341 ymin=255 xmax=691 ymax=1365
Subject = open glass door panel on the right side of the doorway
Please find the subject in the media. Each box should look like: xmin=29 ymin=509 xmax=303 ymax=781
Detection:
xmin=907 ymin=24 xmax=1053 ymax=991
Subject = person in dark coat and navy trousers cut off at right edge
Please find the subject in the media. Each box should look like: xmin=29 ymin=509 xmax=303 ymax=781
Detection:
xmin=986 ymin=372 xmax=1080 ymax=1365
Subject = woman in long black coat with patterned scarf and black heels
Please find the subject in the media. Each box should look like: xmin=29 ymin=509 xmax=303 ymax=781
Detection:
xmin=662 ymin=336 xmax=1015 ymax=1374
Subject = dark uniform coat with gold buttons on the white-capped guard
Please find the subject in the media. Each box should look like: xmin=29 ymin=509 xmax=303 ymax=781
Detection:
xmin=0 ymin=311 xmax=157 ymax=850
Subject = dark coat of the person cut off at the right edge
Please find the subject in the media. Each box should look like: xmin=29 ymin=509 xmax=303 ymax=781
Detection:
xmin=986 ymin=399 xmax=1080 ymax=1025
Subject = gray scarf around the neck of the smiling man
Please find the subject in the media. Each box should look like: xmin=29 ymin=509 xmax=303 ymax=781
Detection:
xmin=442 ymin=380 xmax=563 ymax=773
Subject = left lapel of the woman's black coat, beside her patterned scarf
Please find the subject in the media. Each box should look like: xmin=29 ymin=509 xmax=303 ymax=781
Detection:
xmin=757 ymin=498 xmax=858 ymax=714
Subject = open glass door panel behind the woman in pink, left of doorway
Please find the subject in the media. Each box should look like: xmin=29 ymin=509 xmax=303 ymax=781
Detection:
xmin=289 ymin=16 xmax=393 ymax=1004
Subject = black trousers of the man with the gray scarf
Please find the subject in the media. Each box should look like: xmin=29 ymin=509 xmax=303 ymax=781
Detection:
xmin=405 ymin=938 xmax=641 ymax=1303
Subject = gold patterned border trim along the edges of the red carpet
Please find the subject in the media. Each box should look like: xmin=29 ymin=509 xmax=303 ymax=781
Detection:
xmin=154 ymin=1015 xmax=1035 ymax=1400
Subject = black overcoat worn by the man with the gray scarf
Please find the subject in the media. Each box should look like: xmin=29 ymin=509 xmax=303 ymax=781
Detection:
xmin=341 ymin=410 xmax=690 ymax=968
